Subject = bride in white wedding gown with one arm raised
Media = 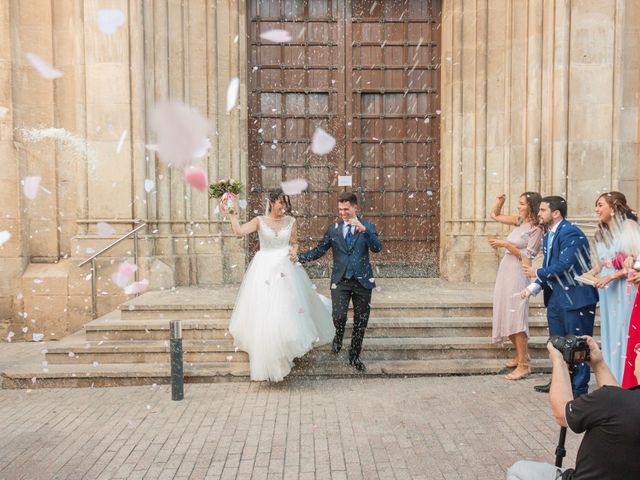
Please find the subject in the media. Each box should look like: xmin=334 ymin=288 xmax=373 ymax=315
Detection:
xmin=229 ymin=189 xmax=335 ymax=382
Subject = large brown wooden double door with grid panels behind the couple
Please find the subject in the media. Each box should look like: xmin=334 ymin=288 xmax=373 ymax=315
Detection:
xmin=247 ymin=0 xmax=441 ymax=276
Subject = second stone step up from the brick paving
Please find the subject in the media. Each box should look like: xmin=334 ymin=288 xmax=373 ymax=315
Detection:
xmin=46 ymin=333 xmax=547 ymax=365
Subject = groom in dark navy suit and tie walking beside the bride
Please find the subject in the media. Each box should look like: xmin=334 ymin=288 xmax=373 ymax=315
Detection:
xmin=298 ymin=192 xmax=382 ymax=372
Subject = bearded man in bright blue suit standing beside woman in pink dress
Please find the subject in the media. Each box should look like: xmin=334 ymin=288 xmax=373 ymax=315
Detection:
xmin=522 ymin=196 xmax=598 ymax=397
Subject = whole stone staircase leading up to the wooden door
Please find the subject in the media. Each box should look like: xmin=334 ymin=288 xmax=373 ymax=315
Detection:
xmin=2 ymin=279 xmax=596 ymax=388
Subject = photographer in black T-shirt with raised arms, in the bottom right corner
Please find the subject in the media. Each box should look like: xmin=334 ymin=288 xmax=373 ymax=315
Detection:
xmin=507 ymin=336 xmax=640 ymax=480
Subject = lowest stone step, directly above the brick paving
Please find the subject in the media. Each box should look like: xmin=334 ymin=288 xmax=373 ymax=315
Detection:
xmin=2 ymin=359 xmax=550 ymax=390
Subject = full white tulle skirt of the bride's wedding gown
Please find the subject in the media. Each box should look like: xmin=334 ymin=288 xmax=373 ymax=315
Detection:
xmin=229 ymin=247 xmax=335 ymax=382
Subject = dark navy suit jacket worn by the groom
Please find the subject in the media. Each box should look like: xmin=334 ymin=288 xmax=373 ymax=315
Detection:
xmin=298 ymin=218 xmax=382 ymax=289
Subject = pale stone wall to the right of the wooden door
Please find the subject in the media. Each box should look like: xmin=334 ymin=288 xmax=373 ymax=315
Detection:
xmin=441 ymin=0 xmax=640 ymax=282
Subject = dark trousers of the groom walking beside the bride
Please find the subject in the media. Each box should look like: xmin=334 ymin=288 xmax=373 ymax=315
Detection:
xmin=331 ymin=277 xmax=371 ymax=358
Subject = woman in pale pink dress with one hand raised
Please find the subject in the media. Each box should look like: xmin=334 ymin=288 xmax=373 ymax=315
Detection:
xmin=489 ymin=192 xmax=543 ymax=380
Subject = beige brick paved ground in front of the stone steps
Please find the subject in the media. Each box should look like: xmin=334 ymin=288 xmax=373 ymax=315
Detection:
xmin=0 ymin=356 xmax=579 ymax=480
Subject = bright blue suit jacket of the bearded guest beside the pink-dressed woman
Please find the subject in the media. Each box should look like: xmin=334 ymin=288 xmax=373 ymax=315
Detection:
xmin=536 ymin=220 xmax=598 ymax=310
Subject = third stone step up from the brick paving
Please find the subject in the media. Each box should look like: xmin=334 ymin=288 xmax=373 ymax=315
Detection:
xmin=85 ymin=317 xmax=547 ymax=341
